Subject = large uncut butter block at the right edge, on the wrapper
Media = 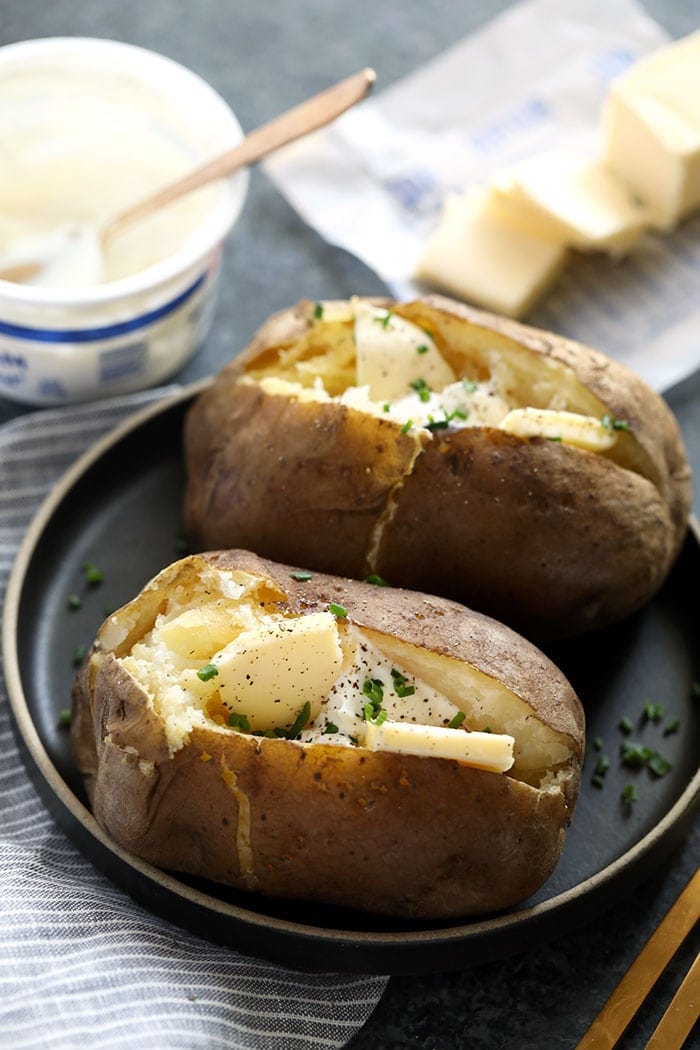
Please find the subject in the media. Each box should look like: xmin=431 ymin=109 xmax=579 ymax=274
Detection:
xmin=603 ymin=32 xmax=700 ymax=229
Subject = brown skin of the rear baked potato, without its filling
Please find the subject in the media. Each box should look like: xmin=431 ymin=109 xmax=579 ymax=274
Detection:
xmin=185 ymin=296 xmax=691 ymax=638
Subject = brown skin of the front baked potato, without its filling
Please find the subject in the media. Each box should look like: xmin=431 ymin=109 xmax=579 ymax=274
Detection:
xmin=71 ymin=551 xmax=584 ymax=919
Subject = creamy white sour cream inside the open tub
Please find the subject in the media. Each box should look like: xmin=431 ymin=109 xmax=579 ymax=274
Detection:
xmin=0 ymin=65 xmax=221 ymax=288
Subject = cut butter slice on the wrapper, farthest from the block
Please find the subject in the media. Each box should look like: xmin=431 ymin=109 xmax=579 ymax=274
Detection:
xmin=416 ymin=188 xmax=566 ymax=317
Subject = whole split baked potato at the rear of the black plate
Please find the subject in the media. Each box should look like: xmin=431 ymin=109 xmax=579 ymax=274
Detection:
xmin=185 ymin=296 xmax=691 ymax=639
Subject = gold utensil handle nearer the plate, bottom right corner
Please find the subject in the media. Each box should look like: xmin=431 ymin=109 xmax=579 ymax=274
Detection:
xmin=576 ymin=868 xmax=700 ymax=1050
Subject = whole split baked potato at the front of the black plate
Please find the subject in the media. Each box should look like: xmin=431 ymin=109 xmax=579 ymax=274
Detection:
xmin=71 ymin=551 xmax=584 ymax=919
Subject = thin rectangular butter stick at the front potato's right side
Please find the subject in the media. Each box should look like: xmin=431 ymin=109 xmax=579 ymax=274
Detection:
xmin=364 ymin=719 xmax=515 ymax=773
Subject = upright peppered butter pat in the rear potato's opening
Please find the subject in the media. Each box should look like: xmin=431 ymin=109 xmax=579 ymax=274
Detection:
xmin=354 ymin=299 xmax=457 ymax=401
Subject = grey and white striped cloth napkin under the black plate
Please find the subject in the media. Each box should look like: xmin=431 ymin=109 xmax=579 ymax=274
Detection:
xmin=0 ymin=391 xmax=387 ymax=1050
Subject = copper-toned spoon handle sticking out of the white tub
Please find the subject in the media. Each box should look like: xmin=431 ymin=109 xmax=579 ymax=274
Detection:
xmin=102 ymin=68 xmax=376 ymax=244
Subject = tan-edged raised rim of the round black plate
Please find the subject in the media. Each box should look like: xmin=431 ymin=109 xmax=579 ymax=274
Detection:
xmin=2 ymin=388 xmax=700 ymax=973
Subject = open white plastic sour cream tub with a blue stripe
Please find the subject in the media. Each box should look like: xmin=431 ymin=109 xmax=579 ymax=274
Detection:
xmin=0 ymin=38 xmax=248 ymax=404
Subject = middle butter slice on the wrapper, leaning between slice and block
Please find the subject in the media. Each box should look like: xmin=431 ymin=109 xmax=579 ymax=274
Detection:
xmin=494 ymin=149 xmax=650 ymax=255
